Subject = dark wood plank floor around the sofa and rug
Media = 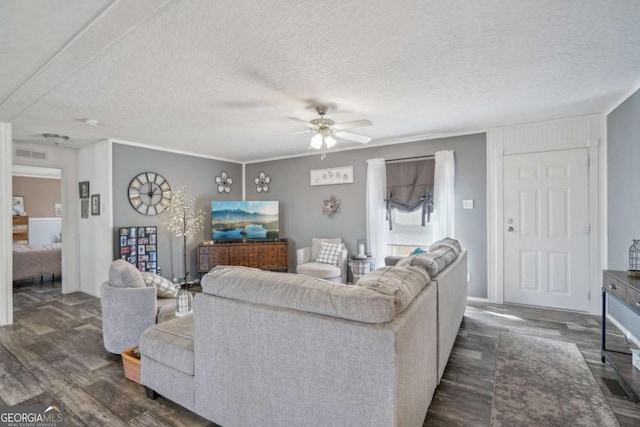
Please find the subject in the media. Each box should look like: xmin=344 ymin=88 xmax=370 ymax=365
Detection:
xmin=0 ymin=280 xmax=640 ymax=426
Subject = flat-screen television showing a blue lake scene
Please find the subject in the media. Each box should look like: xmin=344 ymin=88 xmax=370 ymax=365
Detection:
xmin=211 ymin=201 xmax=280 ymax=240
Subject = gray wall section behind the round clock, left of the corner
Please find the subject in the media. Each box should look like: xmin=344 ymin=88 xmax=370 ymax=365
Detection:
xmin=113 ymin=144 xmax=243 ymax=278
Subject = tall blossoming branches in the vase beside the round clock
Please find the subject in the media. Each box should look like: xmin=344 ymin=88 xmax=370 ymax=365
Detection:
xmin=165 ymin=186 xmax=205 ymax=283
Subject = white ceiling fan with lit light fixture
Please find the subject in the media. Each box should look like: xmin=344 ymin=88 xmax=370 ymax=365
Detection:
xmin=289 ymin=105 xmax=373 ymax=159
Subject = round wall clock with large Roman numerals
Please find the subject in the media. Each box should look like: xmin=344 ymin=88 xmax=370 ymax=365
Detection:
xmin=129 ymin=172 xmax=171 ymax=215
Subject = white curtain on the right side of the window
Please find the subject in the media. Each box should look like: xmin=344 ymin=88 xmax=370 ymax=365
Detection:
xmin=433 ymin=150 xmax=456 ymax=240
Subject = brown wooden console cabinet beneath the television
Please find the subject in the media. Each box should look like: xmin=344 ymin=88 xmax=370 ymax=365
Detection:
xmin=196 ymin=239 xmax=289 ymax=273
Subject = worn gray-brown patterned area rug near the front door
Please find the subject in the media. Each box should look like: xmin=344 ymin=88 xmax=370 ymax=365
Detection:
xmin=491 ymin=333 xmax=619 ymax=427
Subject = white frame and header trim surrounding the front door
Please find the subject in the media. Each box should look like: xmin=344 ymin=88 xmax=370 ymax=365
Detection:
xmin=487 ymin=114 xmax=607 ymax=315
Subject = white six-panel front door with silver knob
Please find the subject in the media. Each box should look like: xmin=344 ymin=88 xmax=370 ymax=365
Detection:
xmin=504 ymin=149 xmax=589 ymax=311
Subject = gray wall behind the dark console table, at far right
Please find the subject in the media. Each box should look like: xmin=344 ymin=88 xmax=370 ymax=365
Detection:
xmin=607 ymin=91 xmax=640 ymax=339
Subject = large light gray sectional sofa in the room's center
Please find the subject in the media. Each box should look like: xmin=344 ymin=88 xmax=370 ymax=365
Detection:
xmin=140 ymin=244 xmax=467 ymax=427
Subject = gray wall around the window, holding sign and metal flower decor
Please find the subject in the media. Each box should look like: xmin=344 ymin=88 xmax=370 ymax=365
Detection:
xmin=246 ymin=134 xmax=487 ymax=298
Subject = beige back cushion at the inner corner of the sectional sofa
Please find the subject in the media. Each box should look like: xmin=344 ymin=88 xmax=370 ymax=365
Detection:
xmin=356 ymin=267 xmax=431 ymax=314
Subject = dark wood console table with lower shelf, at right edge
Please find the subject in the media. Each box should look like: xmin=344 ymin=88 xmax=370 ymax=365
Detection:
xmin=601 ymin=270 xmax=640 ymax=398
